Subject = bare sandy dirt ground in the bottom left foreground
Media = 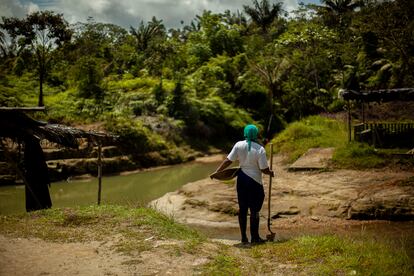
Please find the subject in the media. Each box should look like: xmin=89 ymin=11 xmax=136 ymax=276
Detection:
xmin=0 ymin=235 xmax=225 ymax=276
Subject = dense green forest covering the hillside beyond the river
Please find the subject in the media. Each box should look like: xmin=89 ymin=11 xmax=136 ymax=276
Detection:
xmin=0 ymin=0 xmax=414 ymax=157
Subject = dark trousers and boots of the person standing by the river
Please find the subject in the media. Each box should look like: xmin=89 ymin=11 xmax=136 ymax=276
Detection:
xmin=237 ymin=170 xmax=265 ymax=242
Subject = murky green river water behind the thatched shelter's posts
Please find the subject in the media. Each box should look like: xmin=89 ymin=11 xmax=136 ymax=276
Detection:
xmin=0 ymin=162 xmax=219 ymax=214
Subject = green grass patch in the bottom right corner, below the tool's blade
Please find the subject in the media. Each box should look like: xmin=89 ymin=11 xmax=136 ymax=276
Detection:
xmin=250 ymin=235 xmax=414 ymax=275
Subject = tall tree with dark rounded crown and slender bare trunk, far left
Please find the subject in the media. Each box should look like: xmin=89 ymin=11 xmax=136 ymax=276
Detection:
xmin=0 ymin=11 xmax=72 ymax=106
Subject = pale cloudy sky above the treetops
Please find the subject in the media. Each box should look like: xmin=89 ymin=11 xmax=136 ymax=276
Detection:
xmin=0 ymin=0 xmax=319 ymax=28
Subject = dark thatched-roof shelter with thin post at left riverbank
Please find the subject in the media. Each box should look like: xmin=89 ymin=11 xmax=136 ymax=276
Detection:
xmin=0 ymin=107 xmax=116 ymax=211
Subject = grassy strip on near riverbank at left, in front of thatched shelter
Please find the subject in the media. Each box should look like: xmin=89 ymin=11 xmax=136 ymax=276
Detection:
xmin=0 ymin=205 xmax=205 ymax=253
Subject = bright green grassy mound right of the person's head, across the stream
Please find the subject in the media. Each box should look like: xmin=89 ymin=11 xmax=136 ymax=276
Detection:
xmin=272 ymin=116 xmax=348 ymax=162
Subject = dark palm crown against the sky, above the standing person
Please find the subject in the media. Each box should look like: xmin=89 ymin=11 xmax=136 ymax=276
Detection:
xmin=243 ymin=0 xmax=282 ymax=34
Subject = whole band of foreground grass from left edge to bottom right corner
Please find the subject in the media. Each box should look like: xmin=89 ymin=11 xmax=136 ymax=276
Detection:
xmin=0 ymin=205 xmax=413 ymax=275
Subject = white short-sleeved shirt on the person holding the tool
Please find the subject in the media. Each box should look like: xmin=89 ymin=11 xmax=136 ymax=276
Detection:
xmin=227 ymin=141 xmax=269 ymax=184
